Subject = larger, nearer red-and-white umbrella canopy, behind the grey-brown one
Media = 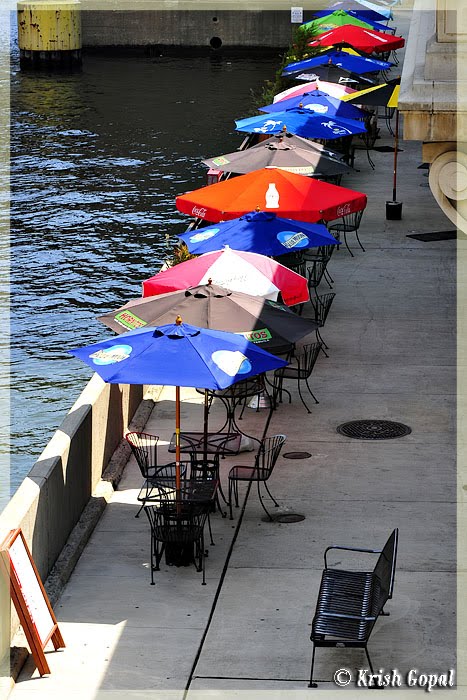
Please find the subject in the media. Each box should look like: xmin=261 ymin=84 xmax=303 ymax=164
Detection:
xmin=143 ymin=246 xmax=310 ymax=308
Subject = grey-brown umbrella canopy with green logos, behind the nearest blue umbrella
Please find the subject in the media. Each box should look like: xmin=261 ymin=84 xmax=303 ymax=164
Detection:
xmin=98 ymin=283 xmax=318 ymax=352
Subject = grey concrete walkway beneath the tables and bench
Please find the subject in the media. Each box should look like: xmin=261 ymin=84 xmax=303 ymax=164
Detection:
xmin=10 ymin=8 xmax=456 ymax=700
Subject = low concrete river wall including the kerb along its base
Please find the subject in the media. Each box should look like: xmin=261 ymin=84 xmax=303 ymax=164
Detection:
xmin=0 ymin=375 xmax=153 ymax=675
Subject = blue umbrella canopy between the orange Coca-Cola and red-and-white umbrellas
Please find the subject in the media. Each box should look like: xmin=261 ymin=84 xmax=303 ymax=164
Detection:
xmin=180 ymin=211 xmax=338 ymax=256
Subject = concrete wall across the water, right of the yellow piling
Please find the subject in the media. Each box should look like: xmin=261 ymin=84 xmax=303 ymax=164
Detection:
xmin=81 ymin=9 xmax=296 ymax=49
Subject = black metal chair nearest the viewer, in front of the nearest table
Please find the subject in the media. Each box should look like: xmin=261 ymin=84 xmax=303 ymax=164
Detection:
xmin=144 ymin=483 xmax=210 ymax=586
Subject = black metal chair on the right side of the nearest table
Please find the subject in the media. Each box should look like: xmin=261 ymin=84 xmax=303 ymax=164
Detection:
xmin=229 ymin=435 xmax=287 ymax=520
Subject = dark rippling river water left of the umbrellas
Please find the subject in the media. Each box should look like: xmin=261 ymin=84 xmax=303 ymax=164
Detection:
xmin=10 ymin=41 xmax=279 ymax=492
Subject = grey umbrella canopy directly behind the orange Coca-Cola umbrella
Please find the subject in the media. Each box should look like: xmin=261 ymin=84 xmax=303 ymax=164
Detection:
xmin=203 ymin=136 xmax=351 ymax=177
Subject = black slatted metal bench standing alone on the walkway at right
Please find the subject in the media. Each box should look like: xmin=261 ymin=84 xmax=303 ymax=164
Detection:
xmin=309 ymin=528 xmax=399 ymax=688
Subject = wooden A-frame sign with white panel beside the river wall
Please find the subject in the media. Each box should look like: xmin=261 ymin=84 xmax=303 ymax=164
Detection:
xmin=0 ymin=528 xmax=65 ymax=676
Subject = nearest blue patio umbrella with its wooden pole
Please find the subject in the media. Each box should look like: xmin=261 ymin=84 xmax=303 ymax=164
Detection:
xmin=69 ymin=317 xmax=288 ymax=488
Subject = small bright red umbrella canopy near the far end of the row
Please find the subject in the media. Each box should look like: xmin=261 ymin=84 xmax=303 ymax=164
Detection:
xmin=308 ymin=24 xmax=405 ymax=53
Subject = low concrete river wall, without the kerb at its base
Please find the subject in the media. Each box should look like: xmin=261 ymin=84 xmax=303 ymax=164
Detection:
xmin=0 ymin=375 xmax=144 ymax=680
